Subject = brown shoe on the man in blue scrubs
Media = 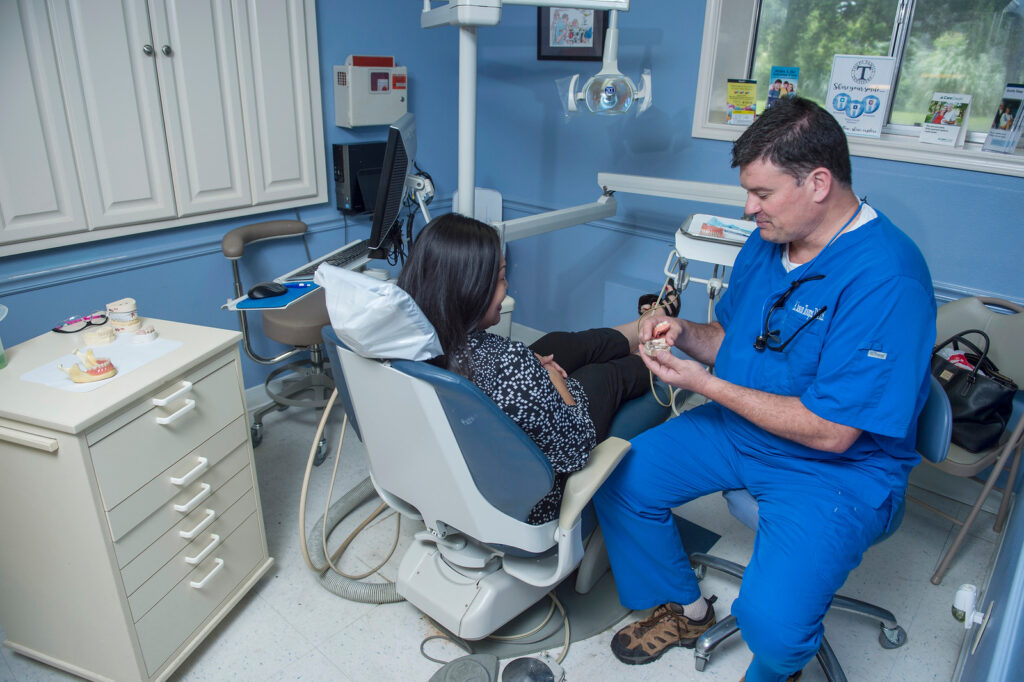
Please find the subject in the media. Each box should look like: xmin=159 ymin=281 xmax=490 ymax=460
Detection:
xmin=611 ymin=597 xmax=717 ymax=666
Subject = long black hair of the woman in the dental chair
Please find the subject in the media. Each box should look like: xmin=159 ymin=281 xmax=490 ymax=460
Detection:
xmin=398 ymin=213 xmax=502 ymax=377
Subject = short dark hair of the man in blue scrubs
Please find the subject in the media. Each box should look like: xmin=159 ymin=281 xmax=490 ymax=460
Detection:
xmin=732 ymin=97 xmax=853 ymax=187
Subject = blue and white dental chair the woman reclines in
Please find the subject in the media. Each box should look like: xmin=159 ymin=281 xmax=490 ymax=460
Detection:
xmin=324 ymin=327 xmax=668 ymax=640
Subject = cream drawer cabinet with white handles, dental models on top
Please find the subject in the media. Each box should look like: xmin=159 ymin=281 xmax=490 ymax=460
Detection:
xmin=0 ymin=319 xmax=273 ymax=680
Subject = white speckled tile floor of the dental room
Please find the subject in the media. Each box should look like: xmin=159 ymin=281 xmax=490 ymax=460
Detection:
xmin=0 ymin=387 xmax=997 ymax=682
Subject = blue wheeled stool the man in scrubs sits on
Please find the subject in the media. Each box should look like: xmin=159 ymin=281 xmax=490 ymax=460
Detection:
xmin=690 ymin=377 xmax=953 ymax=682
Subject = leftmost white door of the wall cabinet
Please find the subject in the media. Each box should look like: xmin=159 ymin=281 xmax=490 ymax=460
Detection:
xmin=0 ymin=0 xmax=85 ymax=243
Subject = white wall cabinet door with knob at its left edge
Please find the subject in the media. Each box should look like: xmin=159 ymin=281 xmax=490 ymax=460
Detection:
xmin=150 ymin=0 xmax=252 ymax=216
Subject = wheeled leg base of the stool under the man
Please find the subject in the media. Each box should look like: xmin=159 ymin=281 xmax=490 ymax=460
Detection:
xmin=690 ymin=553 xmax=906 ymax=682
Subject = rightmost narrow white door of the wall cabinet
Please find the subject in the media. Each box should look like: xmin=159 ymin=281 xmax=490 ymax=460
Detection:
xmin=231 ymin=0 xmax=324 ymax=205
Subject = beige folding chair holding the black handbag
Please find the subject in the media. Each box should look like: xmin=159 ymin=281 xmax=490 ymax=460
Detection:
xmin=911 ymin=297 xmax=1024 ymax=585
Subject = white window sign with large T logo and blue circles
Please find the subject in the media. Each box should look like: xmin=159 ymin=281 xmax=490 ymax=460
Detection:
xmin=825 ymin=54 xmax=896 ymax=137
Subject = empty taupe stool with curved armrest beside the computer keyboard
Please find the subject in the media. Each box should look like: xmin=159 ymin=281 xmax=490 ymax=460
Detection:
xmin=220 ymin=220 xmax=334 ymax=450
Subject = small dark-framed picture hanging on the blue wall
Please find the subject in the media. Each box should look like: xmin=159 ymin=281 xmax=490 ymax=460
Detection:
xmin=537 ymin=7 xmax=608 ymax=61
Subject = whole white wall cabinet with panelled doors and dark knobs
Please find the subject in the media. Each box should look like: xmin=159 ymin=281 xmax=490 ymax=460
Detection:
xmin=0 ymin=0 xmax=327 ymax=253
